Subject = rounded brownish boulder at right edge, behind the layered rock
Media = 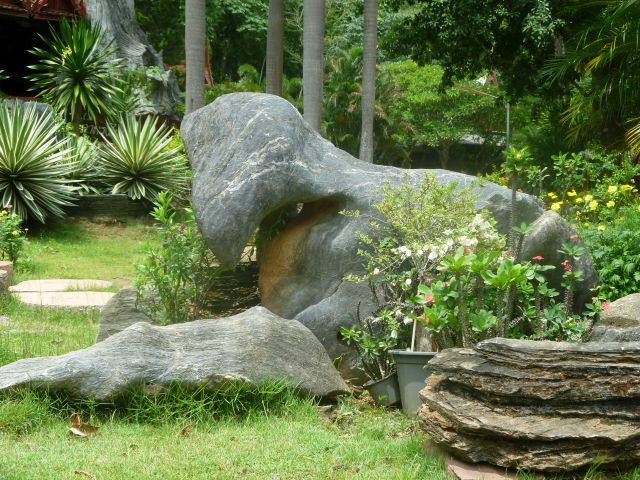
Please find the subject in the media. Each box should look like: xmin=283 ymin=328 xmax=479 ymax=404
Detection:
xmin=589 ymin=293 xmax=640 ymax=342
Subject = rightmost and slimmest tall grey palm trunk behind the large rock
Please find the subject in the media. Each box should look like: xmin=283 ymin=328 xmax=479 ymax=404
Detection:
xmin=360 ymin=0 xmax=378 ymax=163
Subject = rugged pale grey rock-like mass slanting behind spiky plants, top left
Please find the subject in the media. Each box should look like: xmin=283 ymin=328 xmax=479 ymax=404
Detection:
xmin=84 ymin=0 xmax=180 ymax=119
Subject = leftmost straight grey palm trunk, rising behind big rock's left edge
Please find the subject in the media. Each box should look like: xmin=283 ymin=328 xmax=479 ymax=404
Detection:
xmin=184 ymin=0 xmax=206 ymax=113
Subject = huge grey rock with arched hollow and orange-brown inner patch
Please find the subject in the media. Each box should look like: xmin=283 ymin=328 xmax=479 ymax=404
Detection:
xmin=181 ymin=93 xmax=596 ymax=366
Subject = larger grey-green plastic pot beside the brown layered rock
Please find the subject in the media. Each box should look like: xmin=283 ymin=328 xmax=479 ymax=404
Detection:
xmin=389 ymin=350 xmax=437 ymax=415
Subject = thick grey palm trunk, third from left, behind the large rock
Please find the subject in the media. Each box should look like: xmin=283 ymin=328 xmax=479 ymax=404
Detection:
xmin=302 ymin=0 xmax=325 ymax=132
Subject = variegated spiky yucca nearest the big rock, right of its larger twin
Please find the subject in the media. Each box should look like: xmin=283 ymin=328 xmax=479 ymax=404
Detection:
xmin=100 ymin=115 xmax=186 ymax=201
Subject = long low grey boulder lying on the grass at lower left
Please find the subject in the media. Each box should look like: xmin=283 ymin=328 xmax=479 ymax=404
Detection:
xmin=0 ymin=307 xmax=349 ymax=400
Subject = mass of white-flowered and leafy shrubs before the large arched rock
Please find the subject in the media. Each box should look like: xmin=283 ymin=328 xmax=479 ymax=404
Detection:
xmin=343 ymin=175 xmax=600 ymax=358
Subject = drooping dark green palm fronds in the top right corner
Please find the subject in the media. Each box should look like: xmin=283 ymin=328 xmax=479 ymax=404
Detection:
xmin=544 ymin=0 xmax=640 ymax=152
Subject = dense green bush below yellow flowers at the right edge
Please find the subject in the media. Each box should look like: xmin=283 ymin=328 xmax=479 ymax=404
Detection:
xmin=579 ymin=205 xmax=640 ymax=301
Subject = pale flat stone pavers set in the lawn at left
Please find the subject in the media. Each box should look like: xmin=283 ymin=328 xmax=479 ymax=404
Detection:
xmin=9 ymin=279 xmax=115 ymax=308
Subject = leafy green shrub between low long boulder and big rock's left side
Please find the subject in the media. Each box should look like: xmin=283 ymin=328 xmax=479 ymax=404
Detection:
xmin=135 ymin=192 xmax=220 ymax=324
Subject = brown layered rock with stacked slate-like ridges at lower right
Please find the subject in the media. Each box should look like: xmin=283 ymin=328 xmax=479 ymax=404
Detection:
xmin=418 ymin=338 xmax=640 ymax=471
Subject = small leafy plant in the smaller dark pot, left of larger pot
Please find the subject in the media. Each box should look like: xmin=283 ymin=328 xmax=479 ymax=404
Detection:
xmin=340 ymin=307 xmax=408 ymax=406
